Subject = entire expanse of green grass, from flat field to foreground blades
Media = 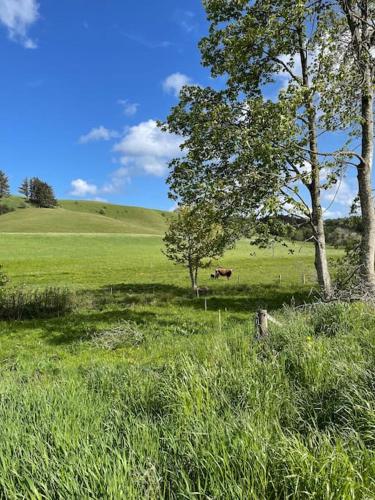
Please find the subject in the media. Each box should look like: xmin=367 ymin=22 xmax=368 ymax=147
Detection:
xmin=0 ymin=229 xmax=375 ymax=499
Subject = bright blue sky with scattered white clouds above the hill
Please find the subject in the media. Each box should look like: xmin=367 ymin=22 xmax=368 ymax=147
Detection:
xmin=0 ymin=0 xmax=364 ymax=217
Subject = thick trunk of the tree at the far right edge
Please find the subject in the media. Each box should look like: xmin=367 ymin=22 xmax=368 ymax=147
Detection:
xmin=357 ymin=63 xmax=375 ymax=291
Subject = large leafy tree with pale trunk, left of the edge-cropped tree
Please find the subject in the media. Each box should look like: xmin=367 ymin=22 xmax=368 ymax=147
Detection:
xmin=166 ymin=0 xmax=364 ymax=296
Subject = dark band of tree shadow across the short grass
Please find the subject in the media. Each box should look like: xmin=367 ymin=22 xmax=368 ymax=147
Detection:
xmin=0 ymin=283 xmax=311 ymax=345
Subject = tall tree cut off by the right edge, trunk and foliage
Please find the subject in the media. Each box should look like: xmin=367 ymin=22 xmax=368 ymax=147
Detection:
xmin=318 ymin=0 xmax=375 ymax=292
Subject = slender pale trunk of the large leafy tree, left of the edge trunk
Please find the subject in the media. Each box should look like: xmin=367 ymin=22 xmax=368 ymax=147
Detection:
xmin=299 ymin=30 xmax=332 ymax=298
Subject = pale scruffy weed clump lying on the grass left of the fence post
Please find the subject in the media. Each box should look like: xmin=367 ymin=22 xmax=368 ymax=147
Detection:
xmin=91 ymin=320 xmax=144 ymax=351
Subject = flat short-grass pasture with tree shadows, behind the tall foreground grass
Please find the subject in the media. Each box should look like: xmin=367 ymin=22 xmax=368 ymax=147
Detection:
xmin=0 ymin=233 xmax=340 ymax=366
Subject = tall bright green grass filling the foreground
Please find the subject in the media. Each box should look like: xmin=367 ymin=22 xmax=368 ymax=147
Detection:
xmin=0 ymin=305 xmax=375 ymax=499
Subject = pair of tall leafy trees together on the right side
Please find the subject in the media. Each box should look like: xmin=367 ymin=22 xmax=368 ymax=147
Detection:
xmin=160 ymin=0 xmax=375 ymax=298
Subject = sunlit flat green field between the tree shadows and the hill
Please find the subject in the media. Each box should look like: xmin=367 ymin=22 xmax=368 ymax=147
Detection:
xmin=0 ymin=233 xmax=341 ymax=291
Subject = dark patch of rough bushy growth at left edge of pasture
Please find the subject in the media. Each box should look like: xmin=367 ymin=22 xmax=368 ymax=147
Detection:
xmin=0 ymin=287 xmax=75 ymax=320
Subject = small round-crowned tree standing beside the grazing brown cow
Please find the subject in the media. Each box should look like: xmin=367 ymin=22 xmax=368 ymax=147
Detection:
xmin=163 ymin=205 xmax=235 ymax=288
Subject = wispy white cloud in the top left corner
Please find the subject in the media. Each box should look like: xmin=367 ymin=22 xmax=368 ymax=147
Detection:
xmin=0 ymin=0 xmax=39 ymax=49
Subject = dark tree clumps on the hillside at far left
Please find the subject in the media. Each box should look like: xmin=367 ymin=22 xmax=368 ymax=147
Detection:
xmin=0 ymin=170 xmax=57 ymax=208
